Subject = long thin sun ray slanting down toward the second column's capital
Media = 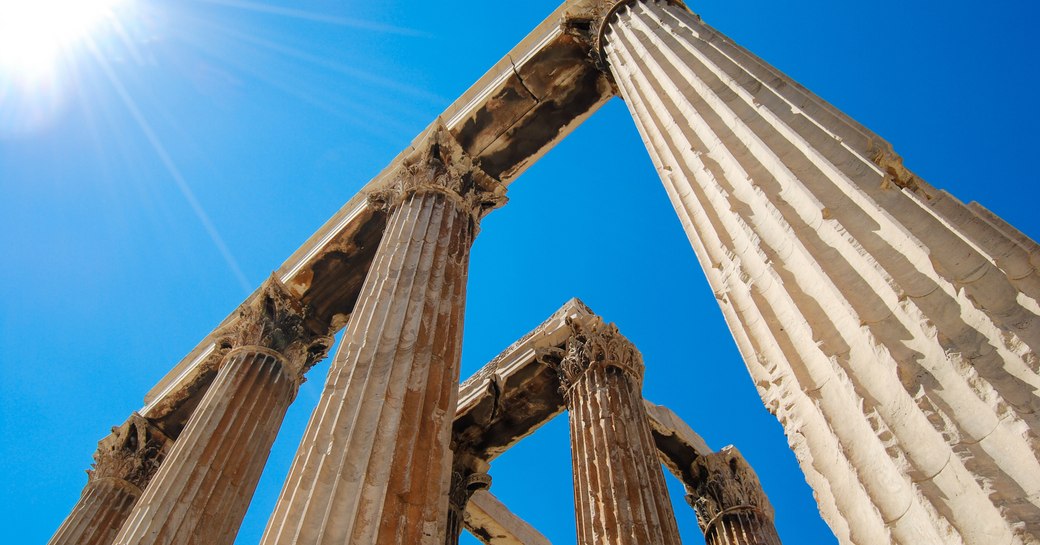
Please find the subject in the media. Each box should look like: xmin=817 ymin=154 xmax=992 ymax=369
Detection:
xmin=87 ymin=37 xmax=254 ymax=294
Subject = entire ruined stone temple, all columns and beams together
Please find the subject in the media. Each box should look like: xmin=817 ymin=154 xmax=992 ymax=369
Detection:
xmin=51 ymin=0 xmax=1040 ymax=545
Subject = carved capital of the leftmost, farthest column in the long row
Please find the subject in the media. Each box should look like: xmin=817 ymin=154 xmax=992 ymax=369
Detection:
xmin=87 ymin=413 xmax=173 ymax=491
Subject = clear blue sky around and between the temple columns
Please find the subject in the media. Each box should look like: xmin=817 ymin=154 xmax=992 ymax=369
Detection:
xmin=0 ymin=0 xmax=1040 ymax=545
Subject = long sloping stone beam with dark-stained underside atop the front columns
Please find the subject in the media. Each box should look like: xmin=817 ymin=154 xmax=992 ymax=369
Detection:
xmin=139 ymin=0 xmax=614 ymax=436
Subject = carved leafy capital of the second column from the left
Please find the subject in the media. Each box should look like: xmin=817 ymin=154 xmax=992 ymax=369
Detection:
xmin=215 ymin=276 xmax=333 ymax=377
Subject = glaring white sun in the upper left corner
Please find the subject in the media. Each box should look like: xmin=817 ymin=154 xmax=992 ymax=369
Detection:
xmin=0 ymin=0 xmax=124 ymax=80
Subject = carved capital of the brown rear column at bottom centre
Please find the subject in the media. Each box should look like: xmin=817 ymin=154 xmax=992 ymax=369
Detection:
xmin=539 ymin=317 xmax=644 ymax=396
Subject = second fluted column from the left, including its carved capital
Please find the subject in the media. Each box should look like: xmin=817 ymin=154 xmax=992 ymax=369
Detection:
xmin=115 ymin=277 xmax=332 ymax=545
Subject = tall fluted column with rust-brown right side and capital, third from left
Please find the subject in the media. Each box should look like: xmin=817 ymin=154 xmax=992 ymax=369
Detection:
xmin=261 ymin=129 xmax=504 ymax=545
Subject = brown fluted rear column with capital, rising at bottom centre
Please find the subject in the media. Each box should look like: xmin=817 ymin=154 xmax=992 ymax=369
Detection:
xmin=556 ymin=318 xmax=680 ymax=545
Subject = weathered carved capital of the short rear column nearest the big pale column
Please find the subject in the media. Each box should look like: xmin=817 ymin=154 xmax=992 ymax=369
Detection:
xmin=690 ymin=446 xmax=773 ymax=530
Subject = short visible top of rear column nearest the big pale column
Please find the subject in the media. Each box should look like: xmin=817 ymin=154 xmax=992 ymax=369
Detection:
xmin=686 ymin=446 xmax=780 ymax=545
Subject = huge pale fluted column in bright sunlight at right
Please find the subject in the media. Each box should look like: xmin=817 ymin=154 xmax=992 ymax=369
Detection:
xmin=599 ymin=0 xmax=1040 ymax=545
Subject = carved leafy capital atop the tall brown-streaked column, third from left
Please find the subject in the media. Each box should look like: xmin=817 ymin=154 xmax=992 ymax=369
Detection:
xmin=368 ymin=125 xmax=506 ymax=222
